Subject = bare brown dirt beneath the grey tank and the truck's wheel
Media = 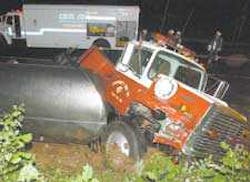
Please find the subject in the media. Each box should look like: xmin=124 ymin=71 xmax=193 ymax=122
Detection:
xmin=30 ymin=142 xmax=146 ymax=175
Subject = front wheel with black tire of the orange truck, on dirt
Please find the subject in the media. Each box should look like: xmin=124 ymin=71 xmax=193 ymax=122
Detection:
xmin=101 ymin=121 xmax=146 ymax=160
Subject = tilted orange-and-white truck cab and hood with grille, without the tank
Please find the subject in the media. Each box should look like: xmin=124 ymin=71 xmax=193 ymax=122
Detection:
xmin=79 ymin=36 xmax=250 ymax=157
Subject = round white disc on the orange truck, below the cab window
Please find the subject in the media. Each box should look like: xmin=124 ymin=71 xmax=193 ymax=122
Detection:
xmin=154 ymin=75 xmax=178 ymax=99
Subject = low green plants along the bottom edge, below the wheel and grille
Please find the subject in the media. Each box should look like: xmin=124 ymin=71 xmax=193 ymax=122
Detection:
xmin=44 ymin=143 xmax=250 ymax=182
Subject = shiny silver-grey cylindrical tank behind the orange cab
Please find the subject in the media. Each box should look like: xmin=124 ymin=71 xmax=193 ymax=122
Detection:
xmin=0 ymin=63 xmax=106 ymax=143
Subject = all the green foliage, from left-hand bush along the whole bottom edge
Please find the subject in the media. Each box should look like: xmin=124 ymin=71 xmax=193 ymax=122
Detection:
xmin=0 ymin=106 xmax=250 ymax=182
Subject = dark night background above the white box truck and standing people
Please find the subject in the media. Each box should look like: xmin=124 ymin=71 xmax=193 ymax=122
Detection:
xmin=0 ymin=0 xmax=250 ymax=49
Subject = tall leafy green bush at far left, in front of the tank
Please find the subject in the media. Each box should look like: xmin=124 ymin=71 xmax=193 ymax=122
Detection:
xmin=0 ymin=105 xmax=41 ymax=182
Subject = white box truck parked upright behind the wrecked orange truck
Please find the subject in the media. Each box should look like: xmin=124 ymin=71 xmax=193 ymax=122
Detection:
xmin=0 ymin=4 xmax=139 ymax=49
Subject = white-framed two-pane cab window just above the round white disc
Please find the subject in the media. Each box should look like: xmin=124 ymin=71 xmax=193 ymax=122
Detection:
xmin=148 ymin=51 xmax=203 ymax=89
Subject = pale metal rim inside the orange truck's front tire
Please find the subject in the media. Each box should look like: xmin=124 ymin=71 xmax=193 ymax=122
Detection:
xmin=107 ymin=132 xmax=130 ymax=156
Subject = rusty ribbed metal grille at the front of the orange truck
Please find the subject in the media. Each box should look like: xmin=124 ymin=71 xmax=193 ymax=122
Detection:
xmin=184 ymin=105 xmax=250 ymax=157
